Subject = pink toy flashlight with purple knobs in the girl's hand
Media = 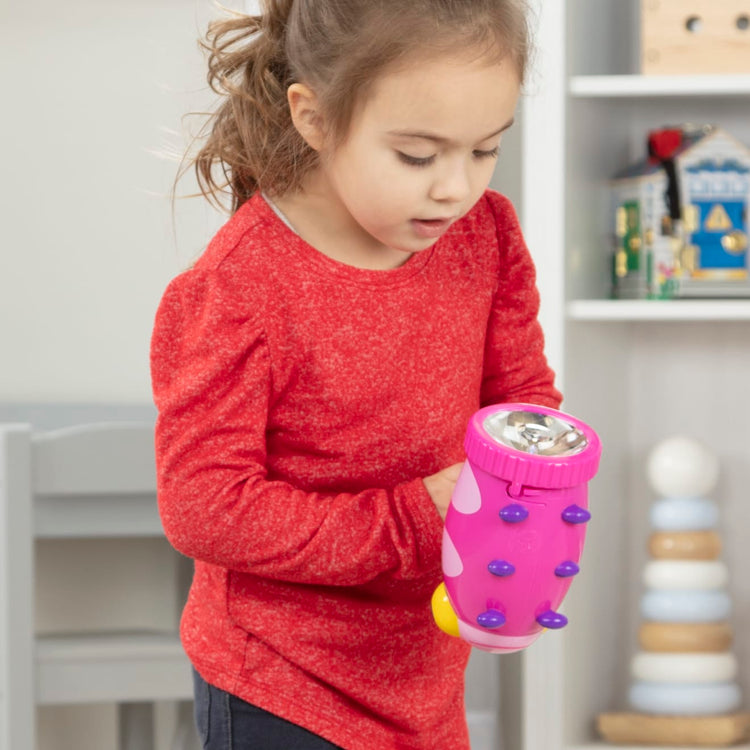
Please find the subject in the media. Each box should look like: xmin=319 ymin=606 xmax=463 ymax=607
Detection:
xmin=432 ymin=404 xmax=601 ymax=652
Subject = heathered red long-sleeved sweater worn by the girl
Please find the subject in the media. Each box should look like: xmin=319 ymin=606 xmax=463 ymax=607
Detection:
xmin=152 ymin=191 xmax=560 ymax=750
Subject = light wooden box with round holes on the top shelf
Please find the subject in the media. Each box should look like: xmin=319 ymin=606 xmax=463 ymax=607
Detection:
xmin=641 ymin=0 xmax=750 ymax=74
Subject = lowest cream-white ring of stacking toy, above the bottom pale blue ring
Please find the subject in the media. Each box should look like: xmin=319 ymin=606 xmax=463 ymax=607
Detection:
xmin=630 ymin=651 xmax=737 ymax=684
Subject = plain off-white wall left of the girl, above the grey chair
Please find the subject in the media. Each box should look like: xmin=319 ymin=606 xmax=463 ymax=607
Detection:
xmin=0 ymin=0 xmax=226 ymax=402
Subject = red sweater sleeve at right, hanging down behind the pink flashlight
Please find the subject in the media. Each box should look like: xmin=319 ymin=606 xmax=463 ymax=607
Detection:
xmin=481 ymin=193 xmax=562 ymax=408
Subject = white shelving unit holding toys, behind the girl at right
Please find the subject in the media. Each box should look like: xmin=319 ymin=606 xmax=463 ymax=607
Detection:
xmin=521 ymin=0 xmax=750 ymax=750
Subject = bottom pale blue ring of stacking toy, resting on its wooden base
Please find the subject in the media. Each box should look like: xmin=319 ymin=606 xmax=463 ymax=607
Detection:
xmin=628 ymin=682 xmax=742 ymax=716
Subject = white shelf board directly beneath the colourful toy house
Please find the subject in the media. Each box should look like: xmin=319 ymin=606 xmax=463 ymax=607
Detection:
xmin=567 ymin=299 xmax=750 ymax=322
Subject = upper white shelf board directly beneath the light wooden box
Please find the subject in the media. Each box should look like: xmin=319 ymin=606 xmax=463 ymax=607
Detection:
xmin=568 ymin=74 xmax=750 ymax=98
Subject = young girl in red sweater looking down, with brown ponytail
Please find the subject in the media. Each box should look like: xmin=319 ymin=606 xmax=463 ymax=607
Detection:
xmin=152 ymin=0 xmax=560 ymax=750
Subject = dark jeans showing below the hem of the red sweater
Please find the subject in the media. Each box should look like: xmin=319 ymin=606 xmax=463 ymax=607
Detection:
xmin=193 ymin=670 xmax=341 ymax=750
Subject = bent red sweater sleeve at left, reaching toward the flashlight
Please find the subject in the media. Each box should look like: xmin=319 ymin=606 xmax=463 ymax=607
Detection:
xmin=151 ymin=270 xmax=440 ymax=586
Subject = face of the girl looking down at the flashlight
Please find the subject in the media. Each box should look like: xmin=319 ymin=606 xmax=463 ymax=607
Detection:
xmin=314 ymin=51 xmax=520 ymax=253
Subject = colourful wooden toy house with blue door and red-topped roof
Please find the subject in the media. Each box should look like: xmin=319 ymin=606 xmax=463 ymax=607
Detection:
xmin=612 ymin=126 xmax=750 ymax=299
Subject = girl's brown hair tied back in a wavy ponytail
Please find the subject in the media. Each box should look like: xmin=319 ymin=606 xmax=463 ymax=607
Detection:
xmin=187 ymin=0 xmax=529 ymax=211
